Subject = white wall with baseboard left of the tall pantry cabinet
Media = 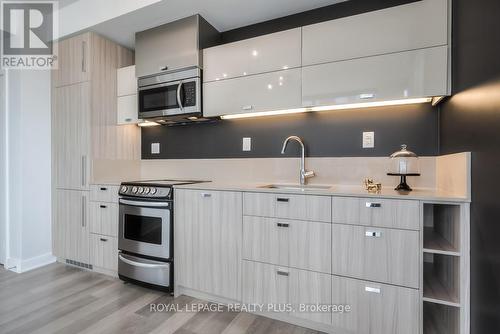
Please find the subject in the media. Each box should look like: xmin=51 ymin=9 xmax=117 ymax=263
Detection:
xmin=6 ymin=70 xmax=54 ymax=272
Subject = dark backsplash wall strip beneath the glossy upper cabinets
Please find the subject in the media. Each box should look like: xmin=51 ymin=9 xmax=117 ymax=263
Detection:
xmin=142 ymin=105 xmax=438 ymax=159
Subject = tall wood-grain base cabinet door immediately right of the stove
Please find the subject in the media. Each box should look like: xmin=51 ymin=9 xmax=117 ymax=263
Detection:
xmin=174 ymin=189 xmax=242 ymax=300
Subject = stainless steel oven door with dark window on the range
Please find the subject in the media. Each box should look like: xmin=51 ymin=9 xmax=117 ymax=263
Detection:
xmin=118 ymin=198 xmax=173 ymax=260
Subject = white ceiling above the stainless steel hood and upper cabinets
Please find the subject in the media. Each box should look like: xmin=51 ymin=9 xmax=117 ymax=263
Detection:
xmin=89 ymin=0 xmax=346 ymax=49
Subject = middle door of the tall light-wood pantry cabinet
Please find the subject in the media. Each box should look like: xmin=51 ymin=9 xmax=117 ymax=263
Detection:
xmin=52 ymin=82 xmax=91 ymax=190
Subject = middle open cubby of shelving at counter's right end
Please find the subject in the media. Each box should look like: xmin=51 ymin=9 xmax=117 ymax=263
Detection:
xmin=423 ymin=255 xmax=460 ymax=307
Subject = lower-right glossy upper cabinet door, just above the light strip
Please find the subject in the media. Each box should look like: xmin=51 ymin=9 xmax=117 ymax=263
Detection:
xmin=302 ymin=46 xmax=450 ymax=107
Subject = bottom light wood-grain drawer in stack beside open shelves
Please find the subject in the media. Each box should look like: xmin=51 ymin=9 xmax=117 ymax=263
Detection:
xmin=332 ymin=276 xmax=420 ymax=334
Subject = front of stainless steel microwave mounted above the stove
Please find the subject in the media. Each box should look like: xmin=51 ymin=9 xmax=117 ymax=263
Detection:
xmin=139 ymin=78 xmax=201 ymax=119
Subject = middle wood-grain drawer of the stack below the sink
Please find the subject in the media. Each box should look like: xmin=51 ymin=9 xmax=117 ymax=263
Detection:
xmin=243 ymin=216 xmax=332 ymax=273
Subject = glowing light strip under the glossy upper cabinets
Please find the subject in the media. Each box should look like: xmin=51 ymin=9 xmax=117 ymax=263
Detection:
xmin=221 ymin=97 xmax=432 ymax=119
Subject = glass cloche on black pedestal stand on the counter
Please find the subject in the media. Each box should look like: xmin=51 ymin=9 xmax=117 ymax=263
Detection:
xmin=387 ymin=145 xmax=420 ymax=191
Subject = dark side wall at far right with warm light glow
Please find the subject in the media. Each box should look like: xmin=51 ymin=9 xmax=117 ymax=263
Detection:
xmin=440 ymin=0 xmax=500 ymax=334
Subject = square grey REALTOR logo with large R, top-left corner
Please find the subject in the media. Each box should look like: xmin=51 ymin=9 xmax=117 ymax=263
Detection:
xmin=1 ymin=1 xmax=57 ymax=69
